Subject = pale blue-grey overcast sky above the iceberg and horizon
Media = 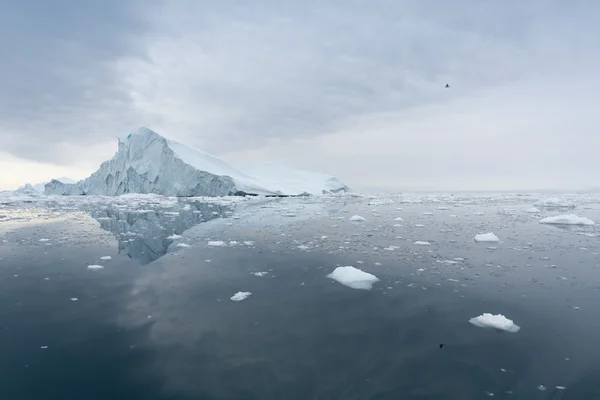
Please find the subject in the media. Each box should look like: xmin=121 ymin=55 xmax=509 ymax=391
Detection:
xmin=0 ymin=0 xmax=600 ymax=192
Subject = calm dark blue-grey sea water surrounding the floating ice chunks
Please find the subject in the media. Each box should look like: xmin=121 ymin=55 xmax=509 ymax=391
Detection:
xmin=0 ymin=195 xmax=600 ymax=400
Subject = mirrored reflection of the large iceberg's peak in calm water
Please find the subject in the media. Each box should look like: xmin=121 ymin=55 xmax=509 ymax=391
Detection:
xmin=90 ymin=201 xmax=231 ymax=264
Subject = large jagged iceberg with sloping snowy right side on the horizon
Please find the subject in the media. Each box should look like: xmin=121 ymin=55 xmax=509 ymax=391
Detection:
xmin=45 ymin=128 xmax=349 ymax=196
